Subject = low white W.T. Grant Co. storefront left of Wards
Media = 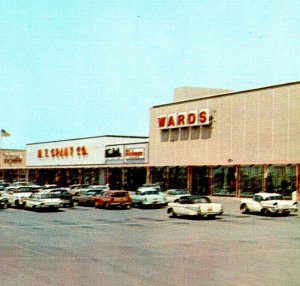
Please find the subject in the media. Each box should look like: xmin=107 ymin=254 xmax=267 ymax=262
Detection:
xmin=26 ymin=136 xmax=148 ymax=190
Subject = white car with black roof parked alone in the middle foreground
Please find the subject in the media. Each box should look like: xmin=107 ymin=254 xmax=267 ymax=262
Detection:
xmin=167 ymin=195 xmax=223 ymax=218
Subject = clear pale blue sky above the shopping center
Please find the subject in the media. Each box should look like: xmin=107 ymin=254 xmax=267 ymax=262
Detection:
xmin=0 ymin=0 xmax=300 ymax=149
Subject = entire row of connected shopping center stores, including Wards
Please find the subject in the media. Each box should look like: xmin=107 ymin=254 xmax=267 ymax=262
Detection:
xmin=1 ymin=82 xmax=300 ymax=197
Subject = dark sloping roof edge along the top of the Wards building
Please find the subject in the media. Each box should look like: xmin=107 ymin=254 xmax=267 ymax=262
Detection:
xmin=152 ymin=81 xmax=300 ymax=108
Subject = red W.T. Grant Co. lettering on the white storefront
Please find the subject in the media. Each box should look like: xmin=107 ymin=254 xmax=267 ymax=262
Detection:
xmin=37 ymin=146 xmax=88 ymax=158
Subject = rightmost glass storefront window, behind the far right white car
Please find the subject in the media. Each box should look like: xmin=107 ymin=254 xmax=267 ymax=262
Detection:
xmin=266 ymin=166 xmax=296 ymax=197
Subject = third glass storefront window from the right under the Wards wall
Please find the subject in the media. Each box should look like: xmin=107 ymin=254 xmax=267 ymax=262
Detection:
xmin=213 ymin=167 xmax=236 ymax=196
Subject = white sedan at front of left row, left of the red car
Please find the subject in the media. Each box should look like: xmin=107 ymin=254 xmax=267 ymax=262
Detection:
xmin=25 ymin=193 xmax=63 ymax=210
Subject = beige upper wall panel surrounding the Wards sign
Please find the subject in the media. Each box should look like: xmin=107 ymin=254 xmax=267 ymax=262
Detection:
xmin=149 ymin=83 xmax=300 ymax=166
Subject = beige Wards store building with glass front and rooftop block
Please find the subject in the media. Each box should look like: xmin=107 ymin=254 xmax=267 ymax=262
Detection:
xmin=149 ymin=82 xmax=300 ymax=197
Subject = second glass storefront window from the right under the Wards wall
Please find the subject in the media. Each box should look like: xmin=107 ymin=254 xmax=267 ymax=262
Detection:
xmin=240 ymin=166 xmax=264 ymax=196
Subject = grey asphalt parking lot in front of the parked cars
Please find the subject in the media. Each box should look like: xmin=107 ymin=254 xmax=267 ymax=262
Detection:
xmin=0 ymin=198 xmax=300 ymax=286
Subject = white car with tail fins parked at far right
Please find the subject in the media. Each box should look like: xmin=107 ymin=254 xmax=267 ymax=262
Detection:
xmin=240 ymin=193 xmax=298 ymax=215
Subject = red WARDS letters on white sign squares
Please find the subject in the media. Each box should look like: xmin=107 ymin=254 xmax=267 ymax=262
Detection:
xmin=158 ymin=109 xmax=211 ymax=129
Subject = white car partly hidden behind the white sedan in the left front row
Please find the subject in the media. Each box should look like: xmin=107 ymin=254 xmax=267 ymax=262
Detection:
xmin=2 ymin=186 xmax=40 ymax=207
